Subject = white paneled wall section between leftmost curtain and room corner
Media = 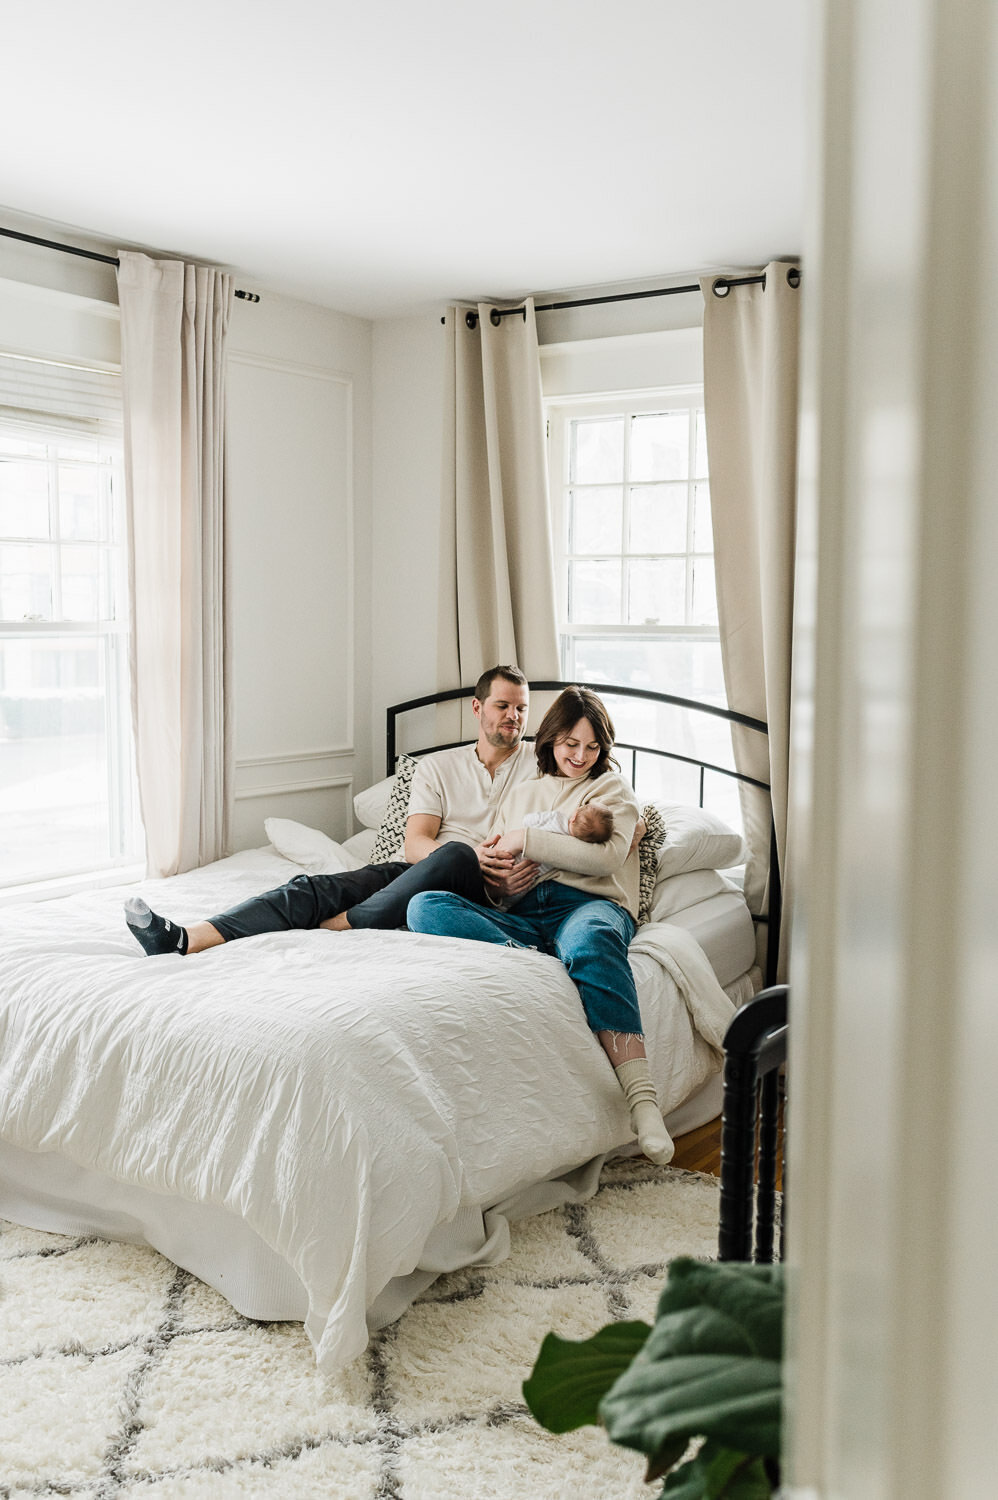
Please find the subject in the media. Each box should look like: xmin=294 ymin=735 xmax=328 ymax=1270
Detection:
xmin=227 ymin=293 xmax=372 ymax=849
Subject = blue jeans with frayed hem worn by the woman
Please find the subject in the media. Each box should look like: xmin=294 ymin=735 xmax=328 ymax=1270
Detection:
xmin=405 ymin=881 xmax=642 ymax=1037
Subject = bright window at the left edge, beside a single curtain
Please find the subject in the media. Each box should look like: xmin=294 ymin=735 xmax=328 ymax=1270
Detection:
xmin=0 ymin=356 xmax=143 ymax=887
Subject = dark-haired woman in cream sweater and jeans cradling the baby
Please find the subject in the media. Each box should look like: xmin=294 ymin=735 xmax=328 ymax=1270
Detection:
xmin=405 ymin=687 xmax=672 ymax=1164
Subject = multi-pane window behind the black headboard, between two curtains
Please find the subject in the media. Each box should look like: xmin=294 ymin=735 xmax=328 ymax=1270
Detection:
xmin=546 ymin=387 xmax=741 ymax=827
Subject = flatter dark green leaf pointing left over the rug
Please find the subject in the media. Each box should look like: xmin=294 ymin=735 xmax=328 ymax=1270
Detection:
xmin=524 ymin=1322 xmax=654 ymax=1434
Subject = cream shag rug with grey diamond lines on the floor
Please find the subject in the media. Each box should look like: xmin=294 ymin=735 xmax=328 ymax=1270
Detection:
xmin=0 ymin=1160 xmax=719 ymax=1500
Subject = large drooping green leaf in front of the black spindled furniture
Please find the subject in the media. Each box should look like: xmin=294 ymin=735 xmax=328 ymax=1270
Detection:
xmin=599 ymin=1260 xmax=783 ymax=1473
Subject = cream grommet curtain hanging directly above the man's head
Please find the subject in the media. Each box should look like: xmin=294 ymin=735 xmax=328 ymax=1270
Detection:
xmin=440 ymin=300 xmax=560 ymax=714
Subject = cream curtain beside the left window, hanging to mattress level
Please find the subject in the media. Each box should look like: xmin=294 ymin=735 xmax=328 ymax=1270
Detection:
xmin=117 ymin=252 xmax=233 ymax=876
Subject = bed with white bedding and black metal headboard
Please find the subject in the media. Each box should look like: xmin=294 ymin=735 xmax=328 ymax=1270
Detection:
xmin=0 ymin=684 xmax=773 ymax=1370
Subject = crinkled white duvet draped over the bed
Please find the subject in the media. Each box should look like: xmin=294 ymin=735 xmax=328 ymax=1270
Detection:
xmin=0 ymin=851 xmax=734 ymax=1370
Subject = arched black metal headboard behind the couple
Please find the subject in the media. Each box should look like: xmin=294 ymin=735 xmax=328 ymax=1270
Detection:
xmin=386 ymin=678 xmax=780 ymax=984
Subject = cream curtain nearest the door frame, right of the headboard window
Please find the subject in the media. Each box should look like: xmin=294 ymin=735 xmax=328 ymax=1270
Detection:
xmin=701 ymin=261 xmax=800 ymax=977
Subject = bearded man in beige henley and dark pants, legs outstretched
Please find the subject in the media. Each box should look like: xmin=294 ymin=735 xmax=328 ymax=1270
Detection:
xmin=125 ymin=666 xmax=537 ymax=954
